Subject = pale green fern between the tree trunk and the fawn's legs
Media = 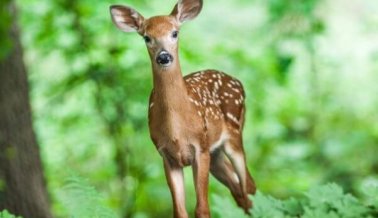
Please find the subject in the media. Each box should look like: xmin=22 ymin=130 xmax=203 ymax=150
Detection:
xmin=60 ymin=176 xmax=117 ymax=218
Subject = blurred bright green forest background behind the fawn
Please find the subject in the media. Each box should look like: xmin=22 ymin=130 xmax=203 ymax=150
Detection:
xmin=11 ymin=0 xmax=378 ymax=217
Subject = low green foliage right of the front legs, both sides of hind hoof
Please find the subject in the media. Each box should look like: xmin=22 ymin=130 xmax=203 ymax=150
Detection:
xmin=213 ymin=184 xmax=378 ymax=218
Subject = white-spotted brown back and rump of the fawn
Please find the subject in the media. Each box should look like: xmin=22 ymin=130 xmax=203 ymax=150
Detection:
xmin=184 ymin=70 xmax=245 ymax=130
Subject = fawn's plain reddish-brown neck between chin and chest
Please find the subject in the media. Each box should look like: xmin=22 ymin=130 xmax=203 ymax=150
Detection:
xmin=153 ymin=60 xmax=189 ymax=113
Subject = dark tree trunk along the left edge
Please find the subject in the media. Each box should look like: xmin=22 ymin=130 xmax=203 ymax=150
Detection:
xmin=0 ymin=3 xmax=51 ymax=218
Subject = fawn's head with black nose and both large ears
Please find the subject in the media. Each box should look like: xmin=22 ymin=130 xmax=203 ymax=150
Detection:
xmin=110 ymin=0 xmax=202 ymax=68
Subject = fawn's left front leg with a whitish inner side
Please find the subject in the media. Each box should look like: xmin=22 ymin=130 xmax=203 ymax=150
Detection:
xmin=164 ymin=158 xmax=188 ymax=218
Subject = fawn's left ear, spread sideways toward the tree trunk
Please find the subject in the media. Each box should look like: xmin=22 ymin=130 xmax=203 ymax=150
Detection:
xmin=110 ymin=5 xmax=144 ymax=32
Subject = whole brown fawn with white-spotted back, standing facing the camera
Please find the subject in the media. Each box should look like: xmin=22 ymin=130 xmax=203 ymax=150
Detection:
xmin=110 ymin=0 xmax=256 ymax=217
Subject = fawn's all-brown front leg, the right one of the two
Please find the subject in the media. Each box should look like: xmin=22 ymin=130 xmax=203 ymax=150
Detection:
xmin=193 ymin=151 xmax=210 ymax=218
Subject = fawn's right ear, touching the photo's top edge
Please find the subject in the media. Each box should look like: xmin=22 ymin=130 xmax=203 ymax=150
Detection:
xmin=171 ymin=0 xmax=202 ymax=24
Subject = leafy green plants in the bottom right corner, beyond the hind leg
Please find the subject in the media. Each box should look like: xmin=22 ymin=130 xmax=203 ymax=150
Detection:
xmin=252 ymin=184 xmax=372 ymax=218
